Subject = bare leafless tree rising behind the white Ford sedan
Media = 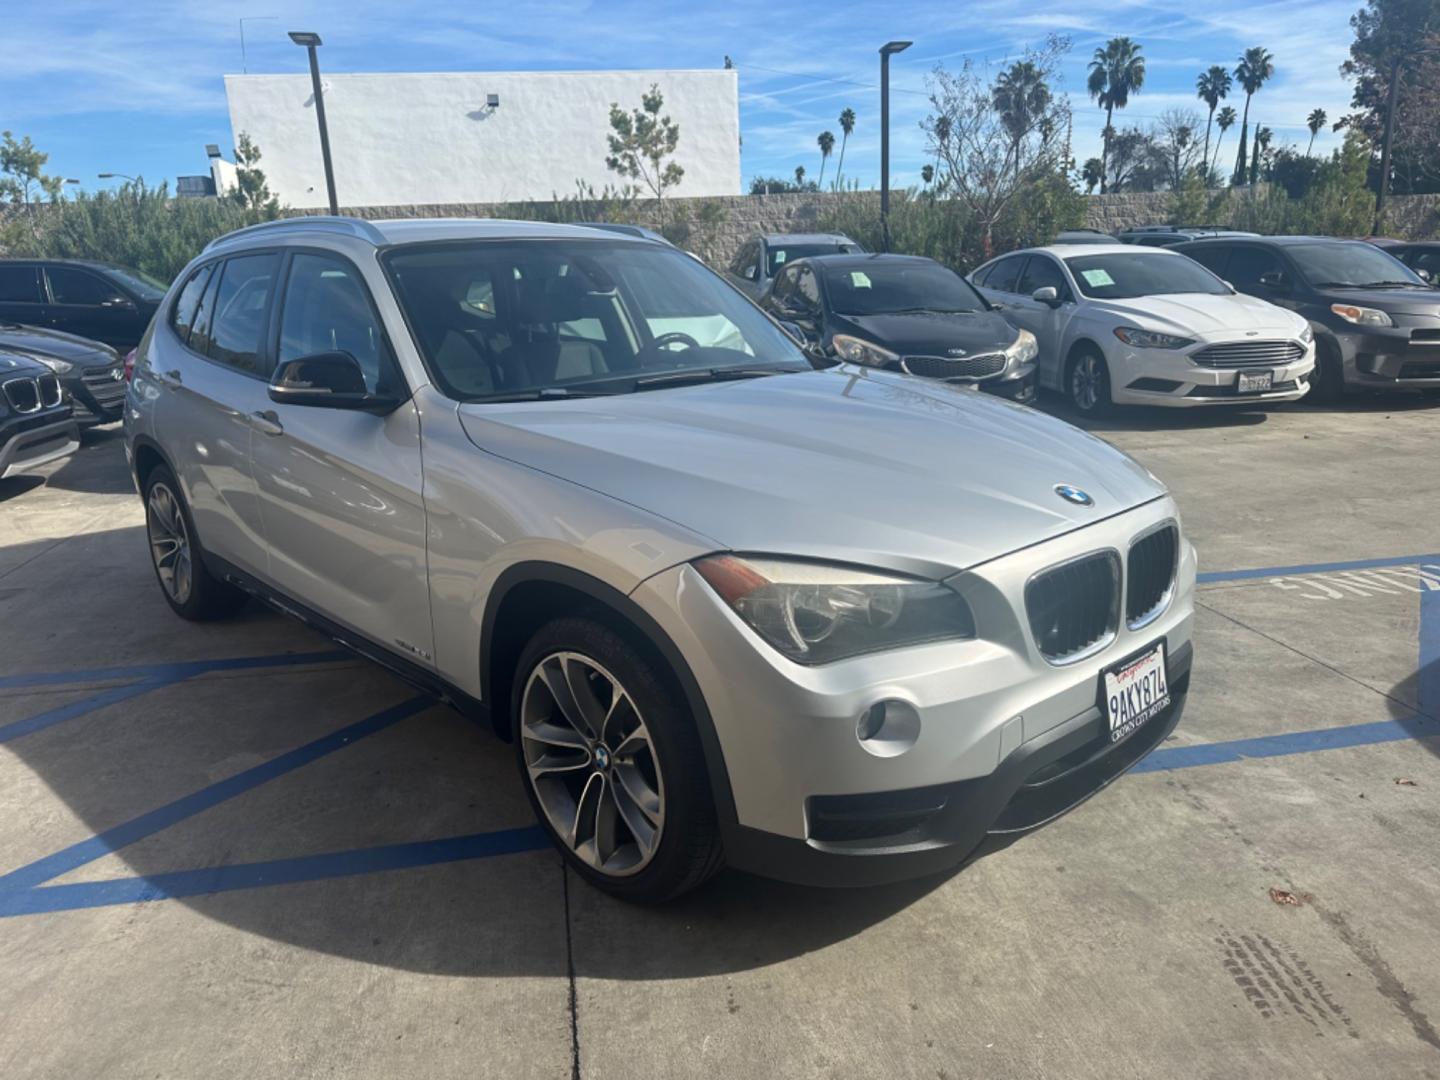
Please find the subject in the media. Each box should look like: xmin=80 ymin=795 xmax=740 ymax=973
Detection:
xmin=920 ymin=36 xmax=1070 ymax=258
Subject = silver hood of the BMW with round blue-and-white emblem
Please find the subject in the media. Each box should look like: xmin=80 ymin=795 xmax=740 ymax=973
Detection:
xmin=459 ymin=366 xmax=1165 ymax=577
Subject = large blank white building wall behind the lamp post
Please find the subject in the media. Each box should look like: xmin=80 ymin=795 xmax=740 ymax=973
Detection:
xmin=225 ymin=69 xmax=740 ymax=207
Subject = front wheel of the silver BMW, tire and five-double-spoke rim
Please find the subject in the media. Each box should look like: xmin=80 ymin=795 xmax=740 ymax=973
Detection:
xmin=511 ymin=618 xmax=720 ymax=903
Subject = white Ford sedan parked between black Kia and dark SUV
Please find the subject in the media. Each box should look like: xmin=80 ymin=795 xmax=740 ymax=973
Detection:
xmin=971 ymin=245 xmax=1315 ymax=415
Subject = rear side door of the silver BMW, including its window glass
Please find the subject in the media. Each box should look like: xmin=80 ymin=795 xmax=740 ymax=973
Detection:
xmin=151 ymin=252 xmax=279 ymax=576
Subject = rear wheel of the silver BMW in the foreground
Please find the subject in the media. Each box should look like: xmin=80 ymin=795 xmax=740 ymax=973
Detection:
xmin=144 ymin=465 xmax=246 ymax=622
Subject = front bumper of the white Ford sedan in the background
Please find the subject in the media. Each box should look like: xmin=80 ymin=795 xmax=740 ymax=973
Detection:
xmin=1106 ymin=340 xmax=1315 ymax=409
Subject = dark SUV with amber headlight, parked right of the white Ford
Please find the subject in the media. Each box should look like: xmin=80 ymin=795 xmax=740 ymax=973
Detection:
xmin=1171 ymin=236 xmax=1440 ymax=400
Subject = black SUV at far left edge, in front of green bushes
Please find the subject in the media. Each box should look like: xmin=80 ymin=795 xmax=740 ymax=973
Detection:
xmin=0 ymin=259 xmax=166 ymax=351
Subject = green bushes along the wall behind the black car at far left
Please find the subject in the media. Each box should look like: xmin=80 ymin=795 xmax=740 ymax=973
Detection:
xmin=0 ymin=183 xmax=279 ymax=289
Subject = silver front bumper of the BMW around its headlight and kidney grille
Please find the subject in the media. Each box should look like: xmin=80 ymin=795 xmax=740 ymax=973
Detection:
xmin=631 ymin=497 xmax=1195 ymax=881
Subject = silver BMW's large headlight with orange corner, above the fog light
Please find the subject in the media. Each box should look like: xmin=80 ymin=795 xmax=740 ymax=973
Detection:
xmin=694 ymin=554 xmax=975 ymax=664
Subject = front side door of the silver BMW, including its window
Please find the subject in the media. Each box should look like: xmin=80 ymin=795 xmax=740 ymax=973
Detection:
xmin=251 ymin=249 xmax=435 ymax=665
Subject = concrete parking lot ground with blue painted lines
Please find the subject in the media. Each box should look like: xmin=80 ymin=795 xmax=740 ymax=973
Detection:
xmin=0 ymin=399 xmax=1440 ymax=1080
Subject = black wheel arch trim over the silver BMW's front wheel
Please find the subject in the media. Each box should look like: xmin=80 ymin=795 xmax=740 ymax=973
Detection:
xmin=480 ymin=562 xmax=737 ymax=825
